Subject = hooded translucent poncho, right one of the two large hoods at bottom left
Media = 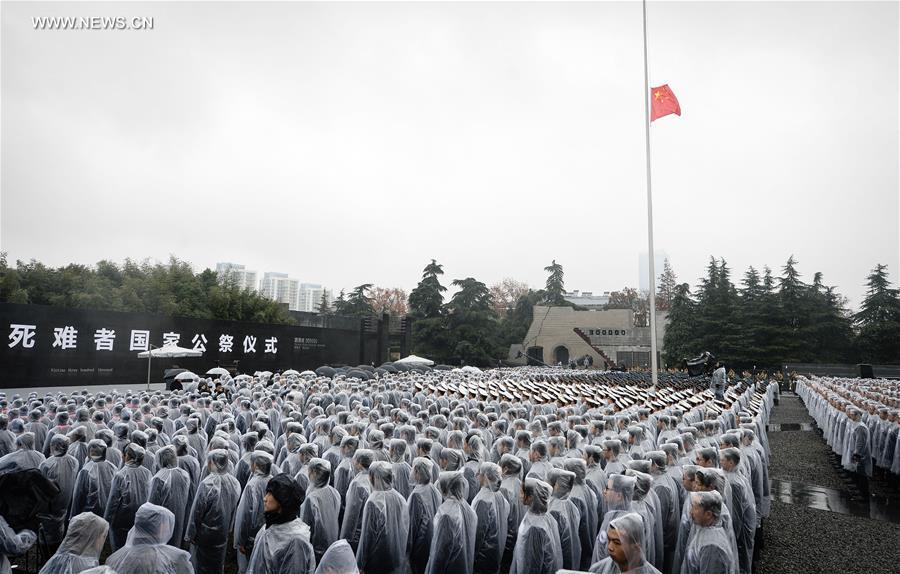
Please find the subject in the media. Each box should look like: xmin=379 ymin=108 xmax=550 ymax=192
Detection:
xmin=106 ymin=504 xmax=194 ymax=574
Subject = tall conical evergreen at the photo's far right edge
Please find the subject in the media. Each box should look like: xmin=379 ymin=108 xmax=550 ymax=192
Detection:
xmin=854 ymin=263 xmax=900 ymax=364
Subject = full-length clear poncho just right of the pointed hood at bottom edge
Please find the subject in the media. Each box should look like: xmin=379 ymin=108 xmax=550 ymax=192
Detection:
xmin=356 ymin=461 xmax=409 ymax=574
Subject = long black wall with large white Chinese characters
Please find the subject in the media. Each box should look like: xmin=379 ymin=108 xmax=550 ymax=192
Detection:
xmin=0 ymin=303 xmax=366 ymax=388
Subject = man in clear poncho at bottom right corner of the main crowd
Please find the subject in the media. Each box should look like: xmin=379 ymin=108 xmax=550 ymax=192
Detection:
xmin=681 ymin=491 xmax=738 ymax=574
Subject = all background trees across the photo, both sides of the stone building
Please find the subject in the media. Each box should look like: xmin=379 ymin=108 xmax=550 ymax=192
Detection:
xmin=0 ymin=254 xmax=900 ymax=369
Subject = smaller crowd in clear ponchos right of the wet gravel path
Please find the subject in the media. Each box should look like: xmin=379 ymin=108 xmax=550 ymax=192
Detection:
xmin=797 ymin=377 xmax=900 ymax=496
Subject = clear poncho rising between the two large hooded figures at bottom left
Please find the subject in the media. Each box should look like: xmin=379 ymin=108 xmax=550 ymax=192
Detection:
xmin=103 ymin=443 xmax=152 ymax=550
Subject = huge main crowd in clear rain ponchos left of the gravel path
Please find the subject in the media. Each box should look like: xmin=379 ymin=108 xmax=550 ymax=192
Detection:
xmin=0 ymin=368 xmax=776 ymax=574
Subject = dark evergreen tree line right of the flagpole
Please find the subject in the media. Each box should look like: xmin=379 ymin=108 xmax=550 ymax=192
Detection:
xmin=660 ymin=256 xmax=900 ymax=369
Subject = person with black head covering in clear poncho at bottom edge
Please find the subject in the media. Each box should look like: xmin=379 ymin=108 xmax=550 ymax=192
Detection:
xmin=247 ymin=474 xmax=316 ymax=574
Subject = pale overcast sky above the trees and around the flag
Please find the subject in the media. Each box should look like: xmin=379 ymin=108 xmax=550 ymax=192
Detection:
xmin=0 ymin=1 xmax=900 ymax=307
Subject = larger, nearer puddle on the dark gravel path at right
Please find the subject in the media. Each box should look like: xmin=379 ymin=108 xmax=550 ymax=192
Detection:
xmin=769 ymin=479 xmax=900 ymax=524
